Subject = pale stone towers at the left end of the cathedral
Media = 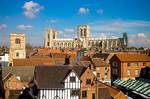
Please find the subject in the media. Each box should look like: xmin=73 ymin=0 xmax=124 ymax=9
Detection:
xmin=44 ymin=29 xmax=58 ymax=48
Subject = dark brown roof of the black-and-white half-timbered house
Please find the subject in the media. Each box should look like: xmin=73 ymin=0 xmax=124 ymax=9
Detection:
xmin=35 ymin=66 xmax=86 ymax=89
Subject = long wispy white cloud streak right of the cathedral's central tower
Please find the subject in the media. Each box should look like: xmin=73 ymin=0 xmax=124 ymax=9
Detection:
xmin=90 ymin=20 xmax=150 ymax=33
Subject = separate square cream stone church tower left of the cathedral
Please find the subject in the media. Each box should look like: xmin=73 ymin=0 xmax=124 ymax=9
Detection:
xmin=9 ymin=33 xmax=26 ymax=63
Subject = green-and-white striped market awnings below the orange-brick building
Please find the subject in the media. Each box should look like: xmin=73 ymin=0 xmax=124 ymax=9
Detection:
xmin=113 ymin=78 xmax=150 ymax=99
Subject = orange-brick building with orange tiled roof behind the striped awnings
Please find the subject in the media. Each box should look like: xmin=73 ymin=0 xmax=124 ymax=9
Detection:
xmin=110 ymin=54 xmax=150 ymax=81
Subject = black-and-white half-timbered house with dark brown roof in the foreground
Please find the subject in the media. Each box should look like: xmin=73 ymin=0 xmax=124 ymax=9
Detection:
xmin=35 ymin=66 xmax=85 ymax=99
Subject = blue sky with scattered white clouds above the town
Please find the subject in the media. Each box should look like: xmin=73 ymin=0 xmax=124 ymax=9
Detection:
xmin=0 ymin=0 xmax=150 ymax=48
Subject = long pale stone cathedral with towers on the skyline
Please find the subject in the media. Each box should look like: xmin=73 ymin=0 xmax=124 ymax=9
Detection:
xmin=44 ymin=25 xmax=128 ymax=50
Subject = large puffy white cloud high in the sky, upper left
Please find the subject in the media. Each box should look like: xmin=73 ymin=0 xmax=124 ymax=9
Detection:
xmin=22 ymin=1 xmax=44 ymax=18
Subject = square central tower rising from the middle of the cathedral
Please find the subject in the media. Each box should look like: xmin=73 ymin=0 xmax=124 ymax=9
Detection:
xmin=77 ymin=25 xmax=91 ymax=48
